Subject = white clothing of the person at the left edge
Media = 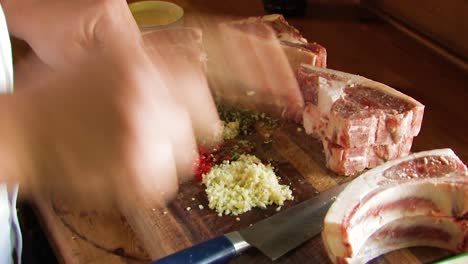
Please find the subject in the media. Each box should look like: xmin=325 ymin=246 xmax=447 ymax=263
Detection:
xmin=0 ymin=2 xmax=22 ymax=264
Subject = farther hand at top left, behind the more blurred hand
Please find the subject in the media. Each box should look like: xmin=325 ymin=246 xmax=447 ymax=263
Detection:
xmin=2 ymin=0 xmax=141 ymax=68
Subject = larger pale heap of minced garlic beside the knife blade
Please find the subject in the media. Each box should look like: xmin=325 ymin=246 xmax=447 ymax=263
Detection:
xmin=203 ymin=155 xmax=293 ymax=216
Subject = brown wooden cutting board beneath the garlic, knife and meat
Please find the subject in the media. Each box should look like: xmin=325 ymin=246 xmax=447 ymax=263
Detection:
xmin=34 ymin=120 xmax=456 ymax=264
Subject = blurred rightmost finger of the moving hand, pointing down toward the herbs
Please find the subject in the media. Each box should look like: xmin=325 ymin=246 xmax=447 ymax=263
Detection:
xmin=144 ymin=28 xmax=221 ymax=144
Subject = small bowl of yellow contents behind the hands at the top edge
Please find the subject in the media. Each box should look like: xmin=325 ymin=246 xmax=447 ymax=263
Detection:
xmin=129 ymin=1 xmax=184 ymax=30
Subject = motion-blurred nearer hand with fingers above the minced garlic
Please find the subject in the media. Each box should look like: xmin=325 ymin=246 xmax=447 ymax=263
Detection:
xmin=4 ymin=21 xmax=221 ymax=254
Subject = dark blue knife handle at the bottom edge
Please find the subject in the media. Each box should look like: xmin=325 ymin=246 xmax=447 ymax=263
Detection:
xmin=151 ymin=235 xmax=237 ymax=264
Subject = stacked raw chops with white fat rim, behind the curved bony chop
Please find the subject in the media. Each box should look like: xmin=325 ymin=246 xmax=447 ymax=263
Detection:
xmin=297 ymin=64 xmax=424 ymax=175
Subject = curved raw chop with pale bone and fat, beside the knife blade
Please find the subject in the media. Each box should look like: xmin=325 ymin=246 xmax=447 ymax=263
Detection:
xmin=322 ymin=149 xmax=468 ymax=263
